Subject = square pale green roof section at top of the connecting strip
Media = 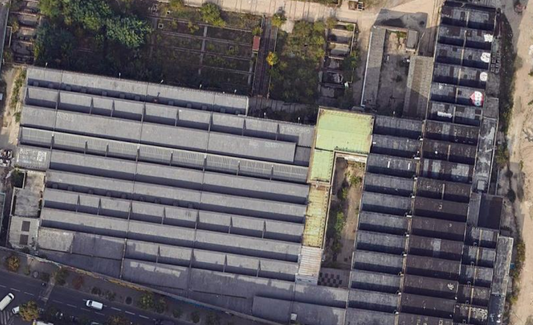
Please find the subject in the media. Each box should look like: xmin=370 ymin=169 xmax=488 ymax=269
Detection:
xmin=315 ymin=109 xmax=374 ymax=154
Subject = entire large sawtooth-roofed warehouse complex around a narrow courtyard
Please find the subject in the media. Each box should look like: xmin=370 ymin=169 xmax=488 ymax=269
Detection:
xmin=9 ymin=2 xmax=513 ymax=325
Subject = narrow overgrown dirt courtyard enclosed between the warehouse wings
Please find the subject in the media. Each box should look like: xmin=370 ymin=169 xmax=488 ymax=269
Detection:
xmin=326 ymin=158 xmax=364 ymax=270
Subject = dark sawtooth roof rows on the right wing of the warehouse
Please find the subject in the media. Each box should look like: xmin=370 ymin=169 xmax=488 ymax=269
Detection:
xmin=347 ymin=2 xmax=512 ymax=325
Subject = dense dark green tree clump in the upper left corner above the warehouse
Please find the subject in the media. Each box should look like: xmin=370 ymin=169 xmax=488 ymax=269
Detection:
xmin=34 ymin=0 xmax=156 ymax=81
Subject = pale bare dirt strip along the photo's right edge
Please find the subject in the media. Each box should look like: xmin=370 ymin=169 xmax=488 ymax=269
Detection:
xmin=500 ymin=1 xmax=533 ymax=325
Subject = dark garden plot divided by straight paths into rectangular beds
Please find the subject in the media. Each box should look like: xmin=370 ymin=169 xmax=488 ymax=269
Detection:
xmin=150 ymin=8 xmax=261 ymax=95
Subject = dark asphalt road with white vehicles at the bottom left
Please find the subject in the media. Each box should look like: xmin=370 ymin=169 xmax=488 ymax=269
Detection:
xmin=0 ymin=271 xmax=189 ymax=325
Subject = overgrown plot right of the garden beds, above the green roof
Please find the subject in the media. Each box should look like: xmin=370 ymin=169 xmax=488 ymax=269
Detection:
xmin=270 ymin=21 xmax=326 ymax=104
